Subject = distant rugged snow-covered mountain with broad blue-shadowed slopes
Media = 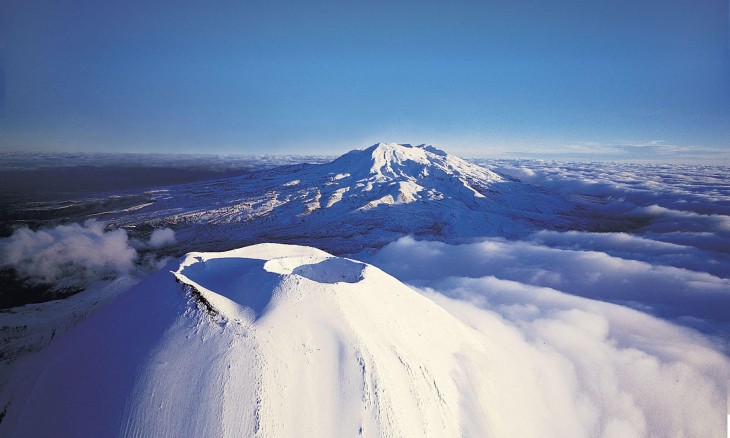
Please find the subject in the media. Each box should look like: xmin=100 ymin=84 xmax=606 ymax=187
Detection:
xmin=112 ymin=143 xmax=573 ymax=253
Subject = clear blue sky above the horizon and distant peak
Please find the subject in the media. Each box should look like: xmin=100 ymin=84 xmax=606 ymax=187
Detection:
xmin=0 ymin=0 xmax=730 ymax=158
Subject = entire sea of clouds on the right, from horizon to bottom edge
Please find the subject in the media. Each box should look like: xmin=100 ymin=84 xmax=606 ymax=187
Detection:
xmin=368 ymin=161 xmax=730 ymax=437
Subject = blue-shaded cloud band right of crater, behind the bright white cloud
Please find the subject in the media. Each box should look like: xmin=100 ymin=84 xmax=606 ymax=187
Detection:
xmin=370 ymin=236 xmax=730 ymax=337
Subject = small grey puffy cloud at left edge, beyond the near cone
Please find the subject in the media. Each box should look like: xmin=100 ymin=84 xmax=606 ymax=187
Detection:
xmin=0 ymin=219 xmax=175 ymax=289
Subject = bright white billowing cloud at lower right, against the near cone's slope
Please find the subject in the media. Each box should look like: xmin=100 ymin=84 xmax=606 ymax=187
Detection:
xmin=424 ymin=284 xmax=730 ymax=438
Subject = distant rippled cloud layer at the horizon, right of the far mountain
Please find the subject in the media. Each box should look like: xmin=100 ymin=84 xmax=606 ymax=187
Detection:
xmin=486 ymin=160 xmax=730 ymax=219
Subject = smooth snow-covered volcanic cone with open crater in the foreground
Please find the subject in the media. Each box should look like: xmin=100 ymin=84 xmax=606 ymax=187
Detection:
xmin=0 ymin=244 xmax=494 ymax=437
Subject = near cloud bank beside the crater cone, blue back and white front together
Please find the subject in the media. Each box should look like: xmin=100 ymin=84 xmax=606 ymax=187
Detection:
xmin=369 ymin=238 xmax=730 ymax=437
